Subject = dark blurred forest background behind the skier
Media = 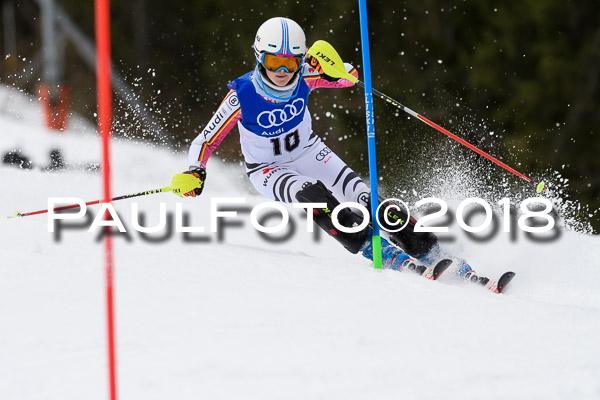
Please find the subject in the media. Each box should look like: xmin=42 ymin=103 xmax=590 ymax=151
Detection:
xmin=0 ymin=0 xmax=600 ymax=232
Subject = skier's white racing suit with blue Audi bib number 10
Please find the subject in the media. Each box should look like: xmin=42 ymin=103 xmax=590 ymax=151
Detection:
xmin=188 ymin=64 xmax=369 ymax=206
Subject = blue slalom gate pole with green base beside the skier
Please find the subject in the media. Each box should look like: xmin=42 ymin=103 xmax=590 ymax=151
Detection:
xmin=358 ymin=0 xmax=381 ymax=268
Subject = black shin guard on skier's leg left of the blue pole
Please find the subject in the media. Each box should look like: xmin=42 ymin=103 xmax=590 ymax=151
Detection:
xmin=296 ymin=181 xmax=369 ymax=254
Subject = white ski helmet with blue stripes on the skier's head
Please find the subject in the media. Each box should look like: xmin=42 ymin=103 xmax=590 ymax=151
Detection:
xmin=252 ymin=17 xmax=306 ymax=64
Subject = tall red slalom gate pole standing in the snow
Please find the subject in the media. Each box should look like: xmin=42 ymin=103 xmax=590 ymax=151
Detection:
xmin=95 ymin=0 xmax=117 ymax=400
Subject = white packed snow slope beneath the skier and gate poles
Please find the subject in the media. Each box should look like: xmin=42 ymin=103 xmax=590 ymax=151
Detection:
xmin=0 ymin=85 xmax=600 ymax=400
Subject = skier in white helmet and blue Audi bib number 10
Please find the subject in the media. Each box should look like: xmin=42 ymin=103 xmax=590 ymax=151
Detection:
xmin=179 ymin=17 xmax=486 ymax=283
